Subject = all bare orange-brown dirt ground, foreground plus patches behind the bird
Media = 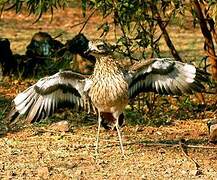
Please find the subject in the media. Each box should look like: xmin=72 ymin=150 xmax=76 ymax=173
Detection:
xmin=0 ymin=9 xmax=217 ymax=180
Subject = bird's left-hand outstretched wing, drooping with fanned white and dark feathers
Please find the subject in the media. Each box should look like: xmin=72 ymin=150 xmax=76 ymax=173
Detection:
xmin=8 ymin=71 xmax=92 ymax=123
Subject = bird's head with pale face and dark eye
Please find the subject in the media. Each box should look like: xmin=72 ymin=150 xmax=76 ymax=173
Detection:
xmin=85 ymin=40 xmax=112 ymax=56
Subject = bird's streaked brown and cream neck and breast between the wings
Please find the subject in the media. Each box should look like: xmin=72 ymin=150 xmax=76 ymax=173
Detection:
xmin=89 ymin=57 xmax=128 ymax=115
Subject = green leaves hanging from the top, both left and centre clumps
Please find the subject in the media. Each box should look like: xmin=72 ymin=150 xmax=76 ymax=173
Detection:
xmin=0 ymin=0 xmax=187 ymax=59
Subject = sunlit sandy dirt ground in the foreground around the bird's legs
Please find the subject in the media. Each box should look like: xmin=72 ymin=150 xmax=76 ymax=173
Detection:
xmin=0 ymin=120 xmax=217 ymax=179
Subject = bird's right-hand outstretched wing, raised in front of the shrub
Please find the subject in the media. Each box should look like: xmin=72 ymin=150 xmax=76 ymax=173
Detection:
xmin=129 ymin=58 xmax=208 ymax=98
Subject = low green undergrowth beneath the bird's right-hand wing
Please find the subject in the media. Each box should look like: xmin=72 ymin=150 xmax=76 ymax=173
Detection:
xmin=125 ymin=94 xmax=209 ymax=127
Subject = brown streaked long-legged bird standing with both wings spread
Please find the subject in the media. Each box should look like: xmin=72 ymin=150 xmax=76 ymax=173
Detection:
xmin=8 ymin=41 xmax=208 ymax=156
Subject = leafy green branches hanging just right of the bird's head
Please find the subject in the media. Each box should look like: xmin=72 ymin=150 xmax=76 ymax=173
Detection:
xmin=82 ymin=0 xmax=191 ymax=59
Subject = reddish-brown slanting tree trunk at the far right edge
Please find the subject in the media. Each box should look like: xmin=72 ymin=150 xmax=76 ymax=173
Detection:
xmin=192 ymin=0 xmax=217 ymax=80
